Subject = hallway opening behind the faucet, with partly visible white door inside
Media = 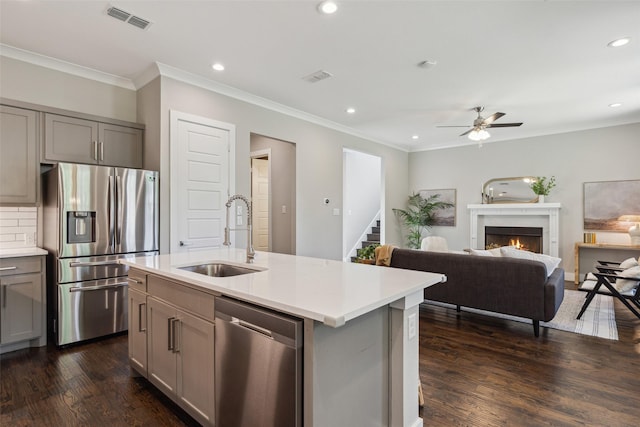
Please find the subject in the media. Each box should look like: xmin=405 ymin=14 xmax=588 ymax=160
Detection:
xmin=250 ymin=134 xmax=296 ymax=255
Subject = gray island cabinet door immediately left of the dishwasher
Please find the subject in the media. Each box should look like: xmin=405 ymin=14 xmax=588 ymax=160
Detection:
xmin=176 ymin=311 xmax=215 ymax=425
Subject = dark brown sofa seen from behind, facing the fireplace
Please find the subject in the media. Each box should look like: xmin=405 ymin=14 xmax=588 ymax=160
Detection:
xmin=390 ymin=248 xmax=564 ymax=337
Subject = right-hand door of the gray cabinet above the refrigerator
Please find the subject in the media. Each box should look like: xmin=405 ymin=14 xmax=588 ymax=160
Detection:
xmin=98 ymin=123 xmax=142 ymax=168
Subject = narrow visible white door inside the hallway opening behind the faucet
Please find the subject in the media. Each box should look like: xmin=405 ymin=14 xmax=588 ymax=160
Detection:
xmin=251 ymin=159 xmax=271 ymax=251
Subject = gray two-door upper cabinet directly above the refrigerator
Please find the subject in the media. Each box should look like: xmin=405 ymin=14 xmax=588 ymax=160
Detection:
xmin=42 ymin=113 xmax=143 ymax=168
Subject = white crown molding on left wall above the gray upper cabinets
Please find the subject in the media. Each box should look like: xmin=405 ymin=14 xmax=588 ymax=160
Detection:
xmin=0 ymin=43 xmax=135 ymax=90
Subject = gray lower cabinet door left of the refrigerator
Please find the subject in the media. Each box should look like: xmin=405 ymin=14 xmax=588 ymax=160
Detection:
xmin=0 ymin=274 xmax=44 ymax=344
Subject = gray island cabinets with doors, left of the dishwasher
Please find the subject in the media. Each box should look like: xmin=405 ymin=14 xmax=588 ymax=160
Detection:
xmin=129 ymin=269 xmax=215 ymax=426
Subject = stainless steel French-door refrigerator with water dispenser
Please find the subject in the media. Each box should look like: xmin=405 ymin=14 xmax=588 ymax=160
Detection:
xmin=43 ymin=163 xmax=159 ymax=345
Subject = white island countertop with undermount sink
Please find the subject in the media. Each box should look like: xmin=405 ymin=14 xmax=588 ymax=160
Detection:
xmin=120 ymin=248 xmax=446 ymax=327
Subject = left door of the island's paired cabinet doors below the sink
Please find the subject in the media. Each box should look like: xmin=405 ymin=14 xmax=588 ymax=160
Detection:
xmin=147 ymin=297 xmax=177 ymax=395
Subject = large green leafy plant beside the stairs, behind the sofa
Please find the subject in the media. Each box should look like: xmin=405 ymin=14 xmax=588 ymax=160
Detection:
xmin=393 ymin=193 xmax=453 ymax=249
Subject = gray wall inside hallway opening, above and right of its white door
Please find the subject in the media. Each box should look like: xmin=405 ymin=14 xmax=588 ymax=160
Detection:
xmin=250 ymin=134 xmax=296 ymax=254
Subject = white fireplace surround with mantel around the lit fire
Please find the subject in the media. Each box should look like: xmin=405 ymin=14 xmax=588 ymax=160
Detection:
xmin=467 ymin=203 xmax=561 ymax=257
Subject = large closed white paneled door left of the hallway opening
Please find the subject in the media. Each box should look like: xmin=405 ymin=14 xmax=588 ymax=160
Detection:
xmin=171 ymin=115 xmax=234 ymax=252
